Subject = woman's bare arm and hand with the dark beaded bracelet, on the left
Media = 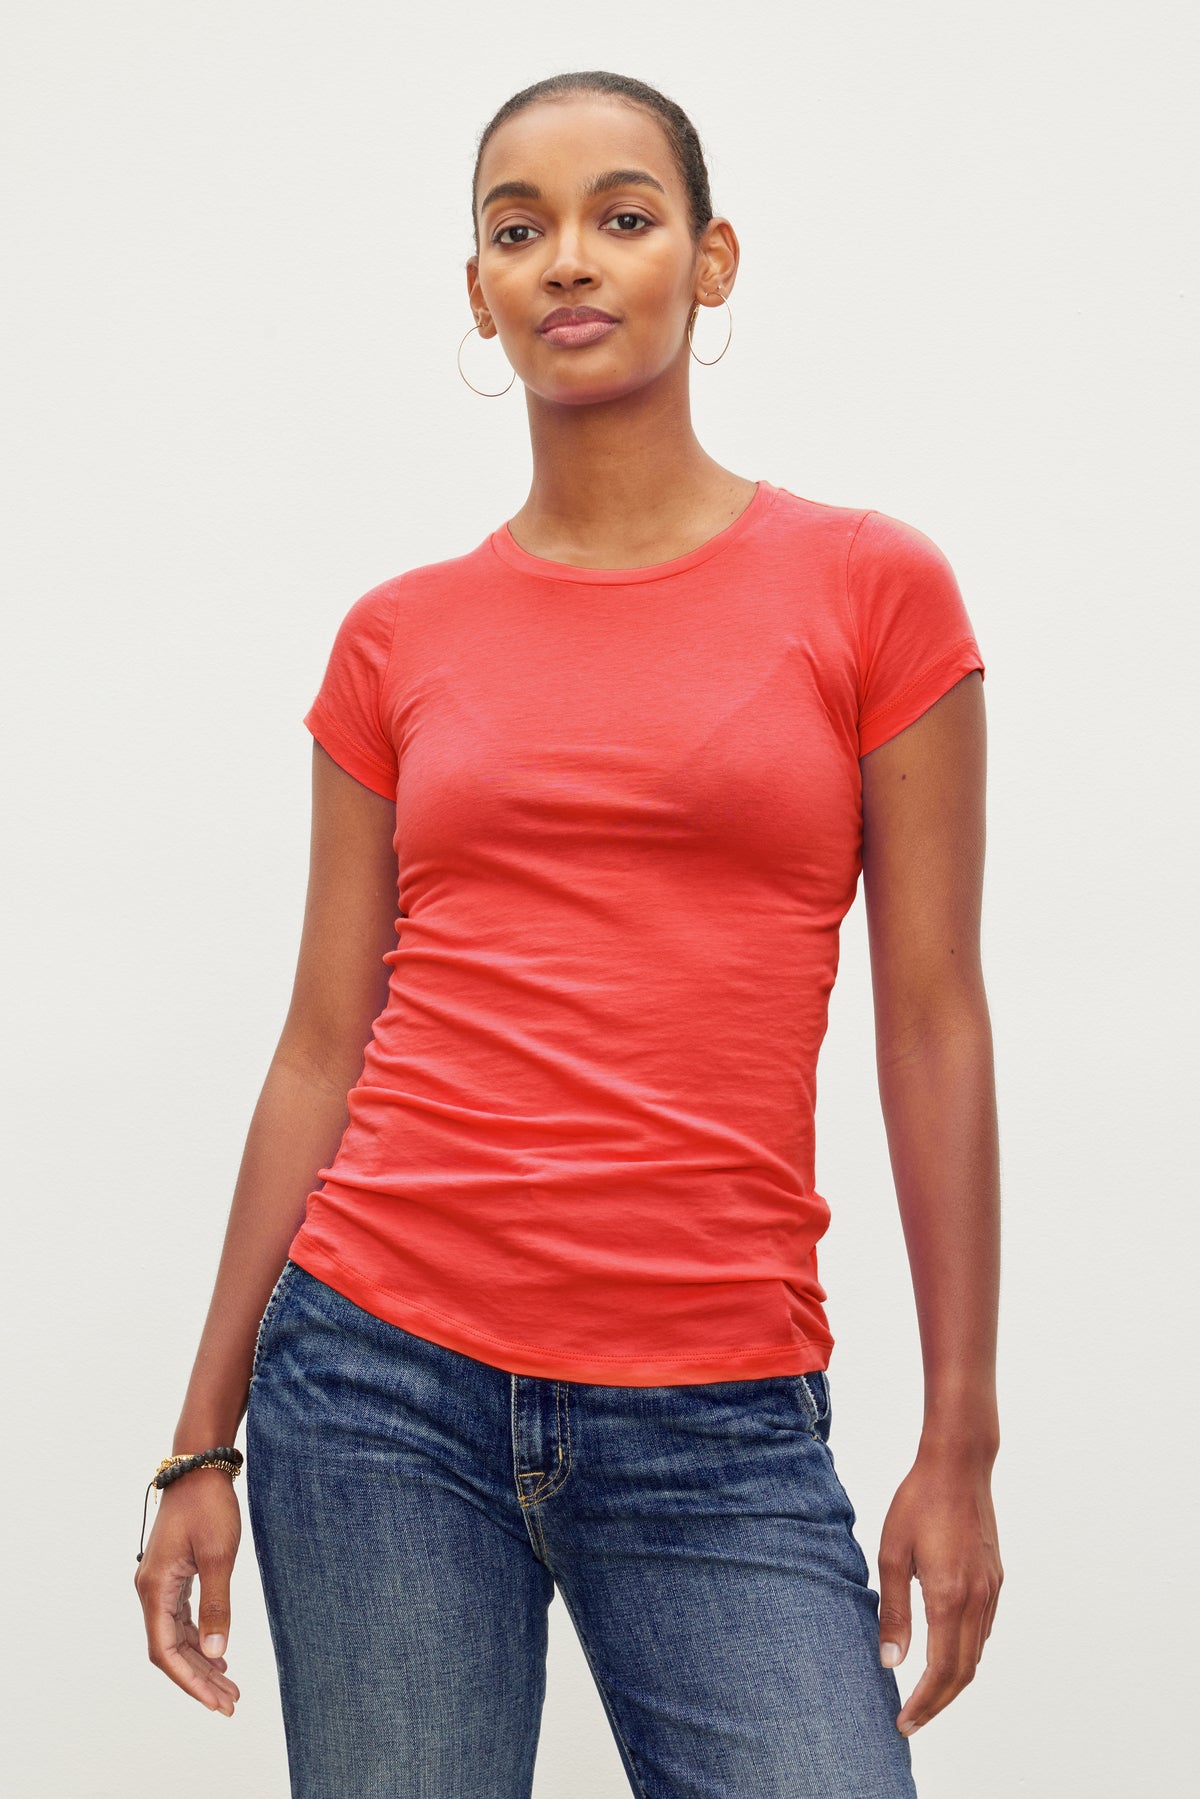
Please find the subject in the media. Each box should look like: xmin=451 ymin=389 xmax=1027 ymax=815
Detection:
xmin=135 ymin=741 xmax=398 ymax=1713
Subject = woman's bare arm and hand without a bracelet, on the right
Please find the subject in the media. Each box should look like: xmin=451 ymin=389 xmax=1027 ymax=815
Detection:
xmin=862 ymin=673 xmax=1004 ymax=1734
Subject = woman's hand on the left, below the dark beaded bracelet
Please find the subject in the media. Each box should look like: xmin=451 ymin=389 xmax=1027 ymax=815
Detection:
xmin=133 ymin=1468 xmax=241 ymax=1718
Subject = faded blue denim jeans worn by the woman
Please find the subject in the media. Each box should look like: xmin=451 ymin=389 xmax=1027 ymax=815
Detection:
xmin=246 ymin=1261 xmax=916 ymax=1799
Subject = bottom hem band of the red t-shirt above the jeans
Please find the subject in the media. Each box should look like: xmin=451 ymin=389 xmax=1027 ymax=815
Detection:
xmin=288 ymin=1227 xmax=833 ymax=1387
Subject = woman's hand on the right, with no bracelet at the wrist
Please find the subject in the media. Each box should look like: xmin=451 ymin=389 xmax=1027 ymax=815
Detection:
xmin=880 ymin=1448 xmax=1004 ymax=1736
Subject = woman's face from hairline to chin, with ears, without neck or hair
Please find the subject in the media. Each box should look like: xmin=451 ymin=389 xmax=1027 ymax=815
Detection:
xmin=466 ymin=95 xmax=736 ymax=405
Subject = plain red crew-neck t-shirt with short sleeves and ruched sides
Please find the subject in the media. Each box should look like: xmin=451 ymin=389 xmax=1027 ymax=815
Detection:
xmin=290 ymin=480 xmax=984 ymax=1387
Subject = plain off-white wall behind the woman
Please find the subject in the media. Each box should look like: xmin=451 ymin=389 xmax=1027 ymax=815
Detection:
xmin=0 ymin=0 xmax=1198 ymax=1799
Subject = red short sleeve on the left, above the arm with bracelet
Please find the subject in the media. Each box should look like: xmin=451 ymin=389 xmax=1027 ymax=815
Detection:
xmin=304 ymin=577 xmax=399 ymax=799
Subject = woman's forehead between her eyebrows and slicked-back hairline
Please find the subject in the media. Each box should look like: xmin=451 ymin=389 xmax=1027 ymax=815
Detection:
xmin=477 ymin=94 xmax=682 ymax=200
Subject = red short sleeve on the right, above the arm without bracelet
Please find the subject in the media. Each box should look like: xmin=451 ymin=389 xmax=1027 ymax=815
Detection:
xmin=846 ymin=511 xmax=984 ymax=756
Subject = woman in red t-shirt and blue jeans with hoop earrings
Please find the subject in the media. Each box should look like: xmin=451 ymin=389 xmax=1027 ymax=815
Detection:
xmin=137 ymin=72 xmax=1002 ymax=1799
